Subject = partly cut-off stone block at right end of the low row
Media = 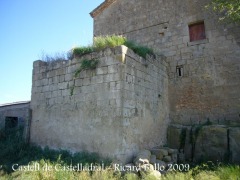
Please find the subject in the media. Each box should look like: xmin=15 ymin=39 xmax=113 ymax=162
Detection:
xmin=229 ymin=127 xmax=240 ymax=163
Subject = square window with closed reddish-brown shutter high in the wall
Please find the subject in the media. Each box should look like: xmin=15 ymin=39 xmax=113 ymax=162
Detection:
xmin=189 ymin=21 xmax=206 ymax=42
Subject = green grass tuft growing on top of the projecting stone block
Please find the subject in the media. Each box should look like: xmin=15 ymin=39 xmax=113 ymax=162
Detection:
xmin=72 ymin=35 xmax=154 ymax=58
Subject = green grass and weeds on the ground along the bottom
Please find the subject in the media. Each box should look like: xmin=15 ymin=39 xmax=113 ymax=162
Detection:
xmin=0 ymin=128 xmax=240 ymax=180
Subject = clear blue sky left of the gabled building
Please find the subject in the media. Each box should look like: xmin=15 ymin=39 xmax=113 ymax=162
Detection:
xmin=0 ymin=0 xmax=103 ymax=104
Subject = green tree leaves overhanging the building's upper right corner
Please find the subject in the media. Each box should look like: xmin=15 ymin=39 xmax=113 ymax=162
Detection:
xmin=206 ymin=0 xmax=240 ymax=23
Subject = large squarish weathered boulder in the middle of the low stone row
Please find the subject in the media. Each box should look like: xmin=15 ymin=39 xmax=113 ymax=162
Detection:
xmin=194 ymin=126 xmax=228 ymax=161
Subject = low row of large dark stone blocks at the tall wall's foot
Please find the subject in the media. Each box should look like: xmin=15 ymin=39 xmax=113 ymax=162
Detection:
xmin=168 ymin=125 xmax=240 ymax=163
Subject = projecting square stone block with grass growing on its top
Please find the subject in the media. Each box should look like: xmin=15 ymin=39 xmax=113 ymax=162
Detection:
xmin=31 ymin=46 xmax=169 ymax=162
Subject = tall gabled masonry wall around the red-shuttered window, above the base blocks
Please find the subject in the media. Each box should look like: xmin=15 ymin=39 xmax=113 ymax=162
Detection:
xmin=94 ymin=0 xmax=240 ymax=125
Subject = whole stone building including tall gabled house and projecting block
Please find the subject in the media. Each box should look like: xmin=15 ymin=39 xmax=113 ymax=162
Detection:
xmin=31 ymin=0 xmax=240 ymax=162
